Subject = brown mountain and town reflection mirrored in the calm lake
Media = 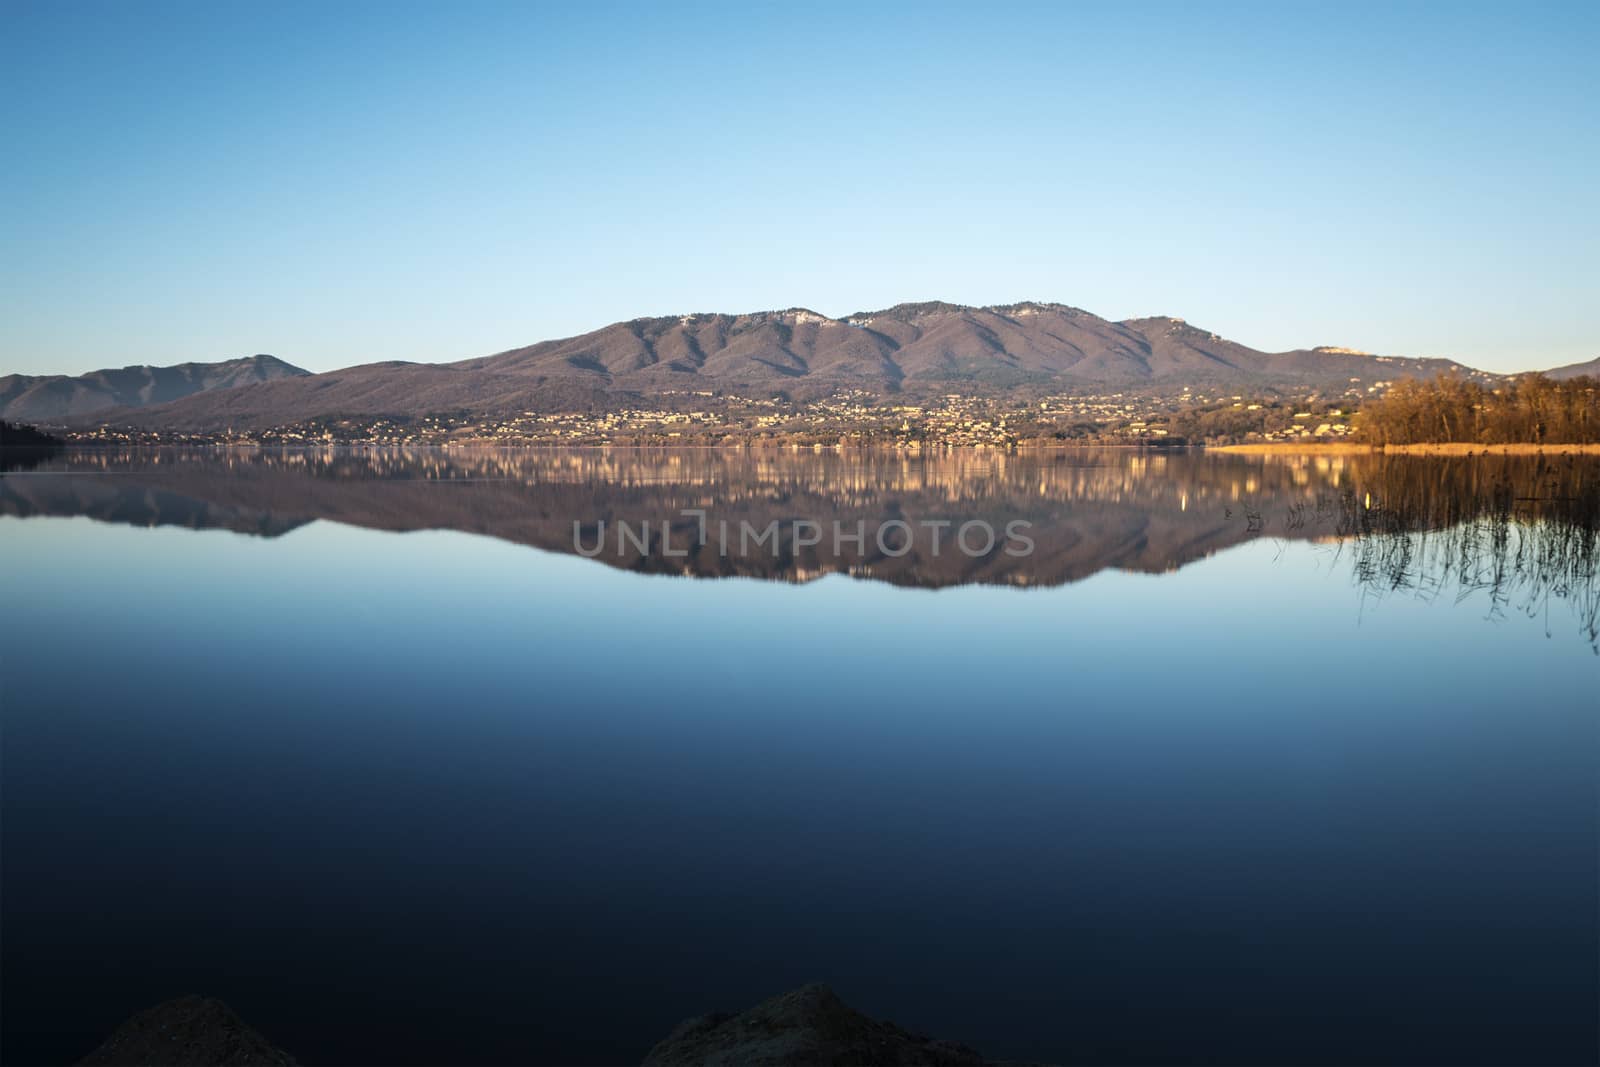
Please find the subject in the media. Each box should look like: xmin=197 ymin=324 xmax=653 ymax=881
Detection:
xmin=0 ymin=450 xmax=1339 ymax=587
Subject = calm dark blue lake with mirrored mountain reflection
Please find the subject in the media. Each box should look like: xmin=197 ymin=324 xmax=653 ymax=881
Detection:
xmin=0 ymin=448 xmax=1600 ymax=1064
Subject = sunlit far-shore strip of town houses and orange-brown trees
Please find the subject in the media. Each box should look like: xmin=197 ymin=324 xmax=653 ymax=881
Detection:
xmin=40 ymin=374 xmax=1600 ymax=451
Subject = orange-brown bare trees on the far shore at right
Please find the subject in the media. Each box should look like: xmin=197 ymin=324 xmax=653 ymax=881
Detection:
xmin=1358 ymin=374 xmax=1600 ymax=445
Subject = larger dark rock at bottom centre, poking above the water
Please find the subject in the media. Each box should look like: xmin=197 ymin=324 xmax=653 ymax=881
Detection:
xmin=645 ymin=985 xmax=989 ymax=1067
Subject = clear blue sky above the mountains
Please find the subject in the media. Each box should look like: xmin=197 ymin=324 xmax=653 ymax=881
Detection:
xmin=0 ymin=0 xmax=1600 ymax=373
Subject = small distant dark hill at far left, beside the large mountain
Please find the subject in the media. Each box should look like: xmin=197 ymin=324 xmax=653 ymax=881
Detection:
xmin=0 ymin=355 xmax=310 ymax=421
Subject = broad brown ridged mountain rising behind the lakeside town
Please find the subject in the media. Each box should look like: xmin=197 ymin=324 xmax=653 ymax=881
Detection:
xmin=32 ymin=302 xmax=1478 ymax=430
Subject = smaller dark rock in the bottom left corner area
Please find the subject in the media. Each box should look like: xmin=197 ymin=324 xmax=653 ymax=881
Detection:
xmin=78 ymin=997 xmax=294 ymax=1067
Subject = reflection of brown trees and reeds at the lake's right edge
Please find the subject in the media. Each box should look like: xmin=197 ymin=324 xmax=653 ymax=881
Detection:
xmin=1336 ymin=456 xmax=1600 ymax=653
